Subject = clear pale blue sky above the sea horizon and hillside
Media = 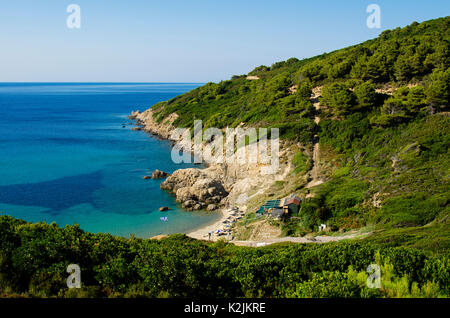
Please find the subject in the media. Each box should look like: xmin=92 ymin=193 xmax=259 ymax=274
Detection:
xmin=0 ymin=0 xmax=450 ymax=82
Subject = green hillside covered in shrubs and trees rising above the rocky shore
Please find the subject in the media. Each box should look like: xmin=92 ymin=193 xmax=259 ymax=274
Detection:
xmin=153 ymin=17 xmax=450 ymax=243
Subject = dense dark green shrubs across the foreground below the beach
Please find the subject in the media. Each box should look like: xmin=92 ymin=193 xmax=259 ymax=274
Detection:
xmin=0 ymin=216 xmax=450 ymax=297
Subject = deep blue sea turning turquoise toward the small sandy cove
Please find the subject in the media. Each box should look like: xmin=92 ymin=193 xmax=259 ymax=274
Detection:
xmin=0 ymin=83 xmax=218 ymax=238
